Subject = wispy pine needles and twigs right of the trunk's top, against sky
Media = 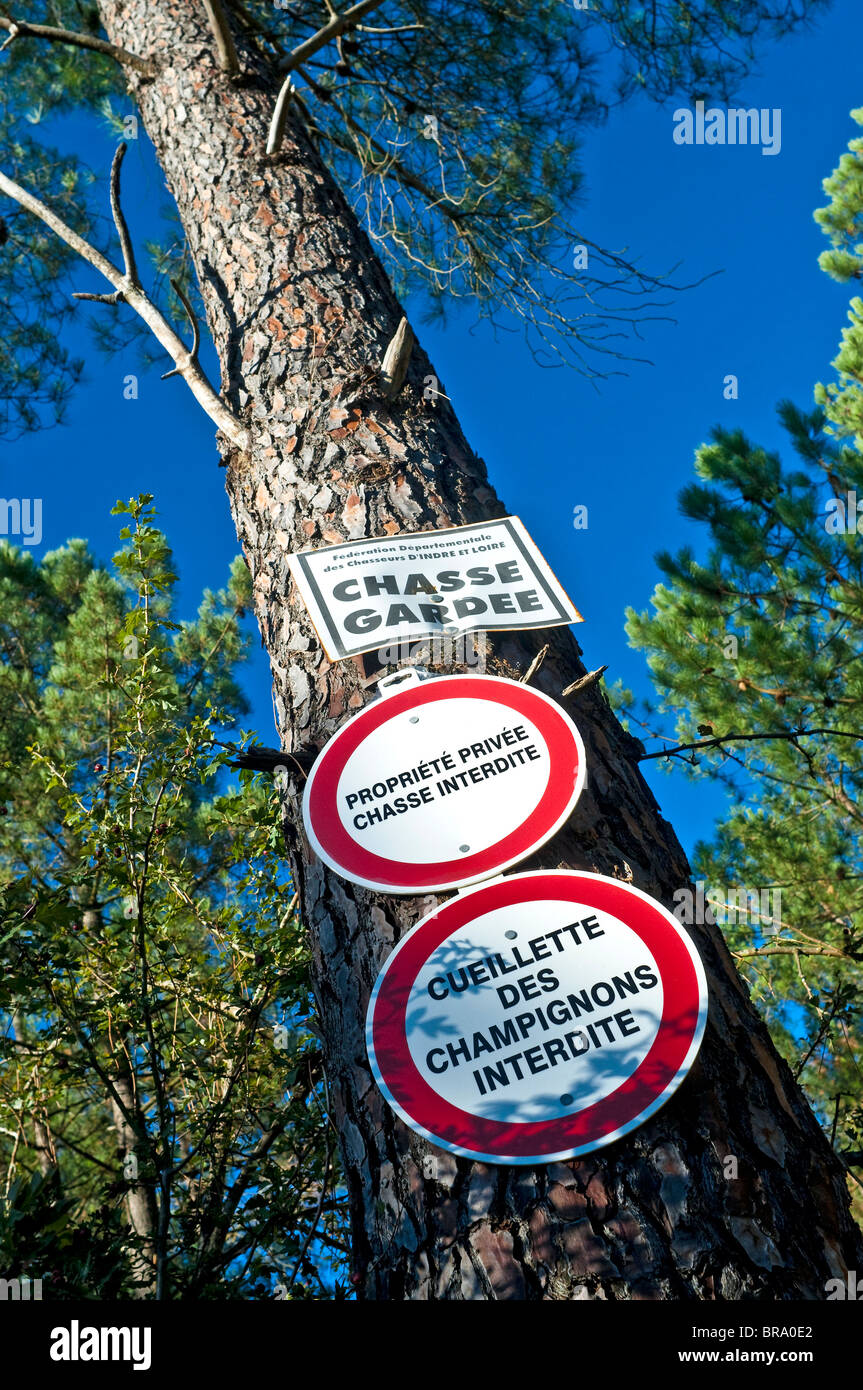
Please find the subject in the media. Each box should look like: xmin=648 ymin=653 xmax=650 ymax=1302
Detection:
xmin=231 ymin=0 xmax=821 ymax=375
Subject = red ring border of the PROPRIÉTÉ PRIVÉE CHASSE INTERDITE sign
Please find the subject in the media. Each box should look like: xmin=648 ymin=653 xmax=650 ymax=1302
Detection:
xmin=307 ymin=676 xmax=580 ymax=891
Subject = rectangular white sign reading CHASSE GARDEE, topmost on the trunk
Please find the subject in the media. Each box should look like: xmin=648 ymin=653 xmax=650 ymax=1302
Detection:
xmin=288 ymin=517 xmax=582 ymax=662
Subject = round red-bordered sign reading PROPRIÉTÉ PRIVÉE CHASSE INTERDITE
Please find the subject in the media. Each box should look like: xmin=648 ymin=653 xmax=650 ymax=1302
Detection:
xmin=303 ymin=671 xmax=585 ymax=894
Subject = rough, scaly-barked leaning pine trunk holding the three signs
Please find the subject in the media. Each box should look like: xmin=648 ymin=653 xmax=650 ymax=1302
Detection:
xmin=99 ymin=0 xmax=862 ymax=1300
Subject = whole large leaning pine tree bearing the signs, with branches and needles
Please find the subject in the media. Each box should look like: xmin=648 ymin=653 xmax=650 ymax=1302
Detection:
xmin=0 ymin=0 xmax=860 ymax=1300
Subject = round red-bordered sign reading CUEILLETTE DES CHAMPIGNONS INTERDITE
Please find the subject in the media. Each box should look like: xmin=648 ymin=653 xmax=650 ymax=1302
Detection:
xmin=365 ymin=870 xmax=707 ymax=1163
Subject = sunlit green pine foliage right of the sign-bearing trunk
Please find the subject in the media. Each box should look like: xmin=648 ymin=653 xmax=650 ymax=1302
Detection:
xmin=617 ymin=113 xmax=863 ymax=1195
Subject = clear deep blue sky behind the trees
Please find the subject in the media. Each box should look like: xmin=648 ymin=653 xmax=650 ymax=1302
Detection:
xmin=0 ymin=0 xmax=863 ymax=849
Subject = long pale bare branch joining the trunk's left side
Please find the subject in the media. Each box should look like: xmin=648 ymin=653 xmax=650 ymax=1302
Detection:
xmin=0 ymin=161 xmax=249 ymax=449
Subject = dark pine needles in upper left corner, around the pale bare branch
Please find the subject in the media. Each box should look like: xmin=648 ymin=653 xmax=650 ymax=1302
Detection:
xmin=0 ymin=0 xmax=204 ymax=422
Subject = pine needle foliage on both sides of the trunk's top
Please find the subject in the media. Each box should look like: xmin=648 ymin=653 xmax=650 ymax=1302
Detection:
xmin=0 ymin=0 xmax=825 ymax=434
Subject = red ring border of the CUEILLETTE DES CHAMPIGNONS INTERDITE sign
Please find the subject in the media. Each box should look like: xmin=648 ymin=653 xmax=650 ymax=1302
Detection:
xmin=370 ymin=872 xmax=700 ymax=1158
